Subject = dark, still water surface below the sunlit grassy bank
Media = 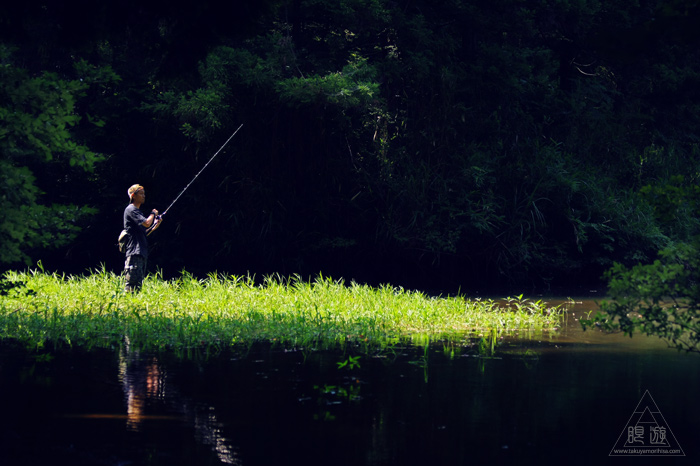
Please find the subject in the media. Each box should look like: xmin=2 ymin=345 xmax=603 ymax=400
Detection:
xmin=0 ymin=301 xmax=700 ymax=466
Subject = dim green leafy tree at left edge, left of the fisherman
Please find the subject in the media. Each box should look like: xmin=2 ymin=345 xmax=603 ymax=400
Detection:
xmin=0 ymin=47 xmax=116 ymax=264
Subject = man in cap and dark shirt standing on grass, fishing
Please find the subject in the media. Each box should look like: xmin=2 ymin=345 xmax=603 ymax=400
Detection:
xmin=124 ymin=184 xmax=158 ymax=292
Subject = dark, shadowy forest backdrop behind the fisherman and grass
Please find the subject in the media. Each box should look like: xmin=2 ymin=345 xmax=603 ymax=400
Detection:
xmin=0 ymin=0 xmax=700 ymax=292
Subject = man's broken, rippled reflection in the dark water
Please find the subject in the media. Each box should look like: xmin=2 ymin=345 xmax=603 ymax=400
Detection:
xmin=119 ymin=338 xmax=242 ymax=465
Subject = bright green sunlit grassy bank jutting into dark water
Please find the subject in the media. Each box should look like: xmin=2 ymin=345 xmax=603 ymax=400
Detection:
xmin=0 ymin=271 xmax=561 ymax=353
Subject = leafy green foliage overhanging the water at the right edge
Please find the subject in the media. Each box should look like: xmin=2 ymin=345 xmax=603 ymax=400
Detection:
xmin=582 ymin=169 xmax=700 ymax=352
